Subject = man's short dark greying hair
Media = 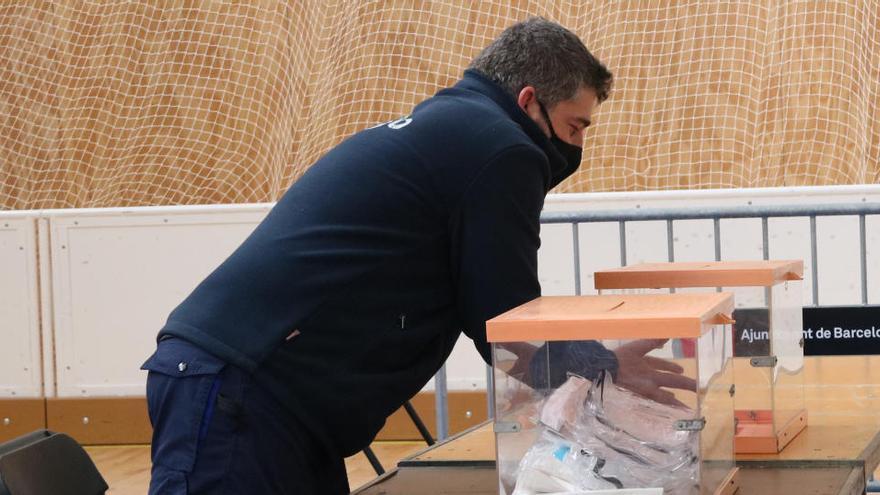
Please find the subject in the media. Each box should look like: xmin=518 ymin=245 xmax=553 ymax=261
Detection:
xmin=469 ymin=17 xmax=612 ymax=107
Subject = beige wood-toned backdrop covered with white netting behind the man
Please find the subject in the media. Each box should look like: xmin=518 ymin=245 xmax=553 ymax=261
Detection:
xmin=0 ymin=0 xmax=880 ymax=209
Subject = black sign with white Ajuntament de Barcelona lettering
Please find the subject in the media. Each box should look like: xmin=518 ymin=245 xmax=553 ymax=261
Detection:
xmin=733 ymin=306 xmax=880 ymax=356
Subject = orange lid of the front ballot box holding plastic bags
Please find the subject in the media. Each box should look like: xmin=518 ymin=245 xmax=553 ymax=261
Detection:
xmin=486 ymin=292 xmax=733 ymax=342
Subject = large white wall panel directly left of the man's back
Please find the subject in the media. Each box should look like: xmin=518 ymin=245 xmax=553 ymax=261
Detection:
xmin=50 ymin=207 xmax=268 ymax=397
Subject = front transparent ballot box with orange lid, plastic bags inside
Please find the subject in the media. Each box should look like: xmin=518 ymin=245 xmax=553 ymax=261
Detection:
xmin=486 ymin=293 xmax=737 ymax=495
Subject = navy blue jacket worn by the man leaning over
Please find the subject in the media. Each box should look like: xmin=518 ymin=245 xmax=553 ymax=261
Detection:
xmin=160 ymin=71 xmax=588 ymax=455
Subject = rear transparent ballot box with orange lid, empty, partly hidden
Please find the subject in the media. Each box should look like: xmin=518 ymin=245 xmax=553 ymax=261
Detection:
xmin=595 ymin=261 xmax=807 ymax=454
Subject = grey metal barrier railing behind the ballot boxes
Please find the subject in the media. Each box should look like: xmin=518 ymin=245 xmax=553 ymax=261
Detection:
xmin=435 ymin=202 xmax=880 ymax=439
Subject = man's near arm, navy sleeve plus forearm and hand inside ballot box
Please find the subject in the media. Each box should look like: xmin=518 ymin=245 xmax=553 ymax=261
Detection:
xmin=452 ymin=146 xmax=694 ymax=401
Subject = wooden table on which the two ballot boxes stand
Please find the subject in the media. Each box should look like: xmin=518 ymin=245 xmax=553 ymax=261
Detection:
xmin=355 ymin=356 xmax=880 ymax=495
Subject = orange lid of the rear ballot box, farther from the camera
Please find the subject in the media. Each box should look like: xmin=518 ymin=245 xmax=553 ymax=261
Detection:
xmin=594 ymin=260 xmax=804 ymax=290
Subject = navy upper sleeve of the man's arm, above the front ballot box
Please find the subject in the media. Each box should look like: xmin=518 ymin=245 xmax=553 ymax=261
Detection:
xmin=451 ymin=146 xmax=549 ymax=365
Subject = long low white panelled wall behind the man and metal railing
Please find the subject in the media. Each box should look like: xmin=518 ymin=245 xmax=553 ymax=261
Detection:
xmin=0 ymin=186 xmax=880 ymax=396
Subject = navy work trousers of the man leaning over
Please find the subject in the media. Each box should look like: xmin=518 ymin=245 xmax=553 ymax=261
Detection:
xmin=143 ymin=338 xmax=349 ymax=495
